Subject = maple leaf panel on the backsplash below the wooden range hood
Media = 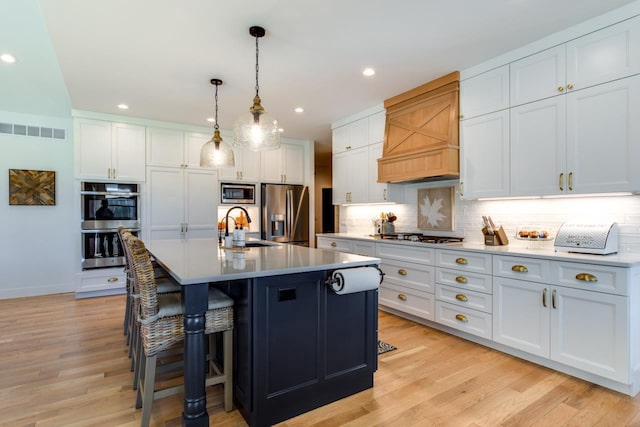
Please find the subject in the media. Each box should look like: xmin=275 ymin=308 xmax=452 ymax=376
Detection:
xmin=418 ymin=186 xmax=455 ymax=231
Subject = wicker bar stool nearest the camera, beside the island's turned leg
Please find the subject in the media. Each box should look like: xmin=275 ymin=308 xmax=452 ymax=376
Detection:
xmin=128 ymin=236 xmax=233 ymax=426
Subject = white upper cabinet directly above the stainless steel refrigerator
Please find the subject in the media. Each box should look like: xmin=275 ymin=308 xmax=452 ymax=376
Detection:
xmin=261 ymin=143 xmax=306 ymax=184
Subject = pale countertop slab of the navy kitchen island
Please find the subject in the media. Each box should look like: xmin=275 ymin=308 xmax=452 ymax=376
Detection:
xmin=145 ymin=239 xmax=380 ymax=285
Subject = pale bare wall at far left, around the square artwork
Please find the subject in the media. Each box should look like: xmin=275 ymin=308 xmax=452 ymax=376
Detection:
xmin=0 ymin=111 xmax=80 ymax=298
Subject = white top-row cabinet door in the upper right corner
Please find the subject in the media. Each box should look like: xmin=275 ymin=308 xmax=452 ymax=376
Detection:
xmin=567 ymin=17 xmax=640 ymax=90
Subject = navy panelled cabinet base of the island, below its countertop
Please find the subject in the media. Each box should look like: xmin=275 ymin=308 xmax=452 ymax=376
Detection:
xmin=221 ymin=271 xmax=377 ymax=426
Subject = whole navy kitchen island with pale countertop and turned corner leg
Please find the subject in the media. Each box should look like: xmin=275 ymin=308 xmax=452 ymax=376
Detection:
xmin=147 ymin=239 xmax=379 ymax=426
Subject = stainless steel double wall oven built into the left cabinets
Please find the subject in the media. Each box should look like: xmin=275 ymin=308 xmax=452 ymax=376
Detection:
xmin=80 ymin=182 xmax=140 ymax=270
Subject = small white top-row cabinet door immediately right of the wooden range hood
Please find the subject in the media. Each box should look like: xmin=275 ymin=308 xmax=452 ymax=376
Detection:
xmin=460 ymin=65 xmax=509 ymax=120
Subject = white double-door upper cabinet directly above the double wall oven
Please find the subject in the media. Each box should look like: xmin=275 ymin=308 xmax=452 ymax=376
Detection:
xmin=75 ymin=118 xmax=145 ymax=182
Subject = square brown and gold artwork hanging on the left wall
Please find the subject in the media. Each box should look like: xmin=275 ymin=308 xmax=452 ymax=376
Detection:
xmin=9 ymin=169 xmax=56 ymax=206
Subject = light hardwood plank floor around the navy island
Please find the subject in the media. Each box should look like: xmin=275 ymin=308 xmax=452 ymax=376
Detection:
xmin=0 ymin=294 xmax=640 ymax=427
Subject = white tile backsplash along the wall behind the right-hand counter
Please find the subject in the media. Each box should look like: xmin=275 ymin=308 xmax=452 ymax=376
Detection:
xmin=340 ymin=180 xmax=640 ymax=254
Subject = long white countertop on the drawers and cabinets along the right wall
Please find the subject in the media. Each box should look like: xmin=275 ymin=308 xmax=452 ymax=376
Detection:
xmin=317 ymin=233 xmax=640 ymax=267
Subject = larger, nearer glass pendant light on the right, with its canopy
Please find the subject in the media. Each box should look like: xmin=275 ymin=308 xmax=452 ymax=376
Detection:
xmin=233 ymin=27 xmax=280 ymax=151
